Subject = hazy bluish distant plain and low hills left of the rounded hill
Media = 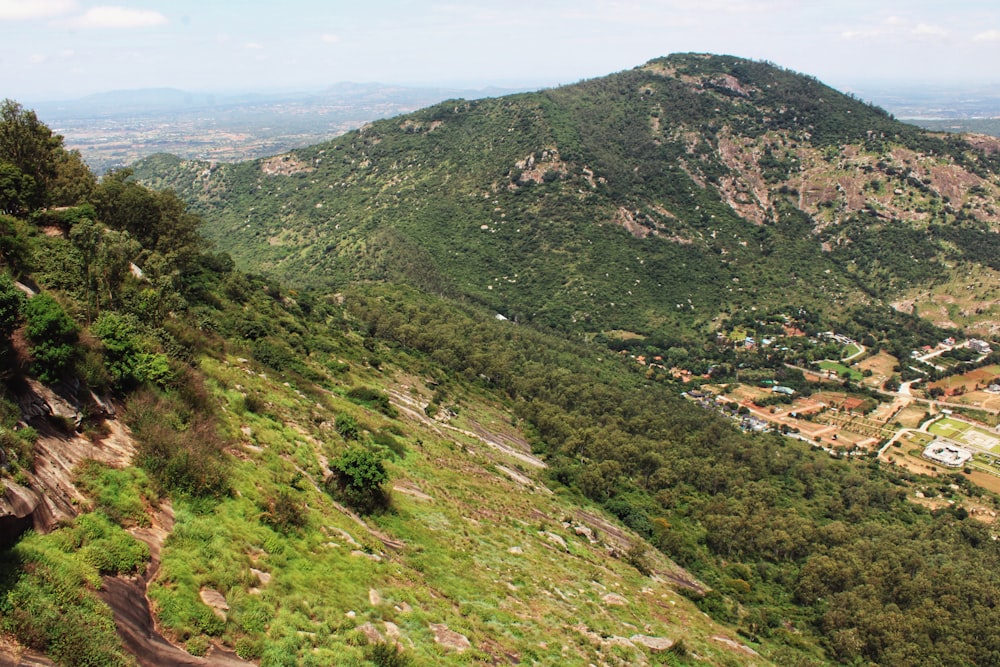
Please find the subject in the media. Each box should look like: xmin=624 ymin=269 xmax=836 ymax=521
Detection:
xmin=36 ymin=83 xmax=528 ymax=173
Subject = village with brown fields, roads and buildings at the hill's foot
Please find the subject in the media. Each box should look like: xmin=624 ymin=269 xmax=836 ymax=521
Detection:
xmin=660 ymin=328 xmax=1000 ymax=491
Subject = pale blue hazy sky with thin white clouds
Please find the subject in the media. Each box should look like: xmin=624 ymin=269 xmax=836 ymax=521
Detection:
xmin=0 ymin=0 xmax=1000 ymax=104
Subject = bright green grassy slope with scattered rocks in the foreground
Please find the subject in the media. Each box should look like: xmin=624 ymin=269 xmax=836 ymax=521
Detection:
xmin=150 ymin=350 xmax=747 ymax=665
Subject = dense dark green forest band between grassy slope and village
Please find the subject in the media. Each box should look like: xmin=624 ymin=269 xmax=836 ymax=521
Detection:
xmin=354 ymin=288 xmax=1000 ymax=665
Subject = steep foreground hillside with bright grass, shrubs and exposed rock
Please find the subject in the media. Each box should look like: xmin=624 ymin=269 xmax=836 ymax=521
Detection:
xmin=0 ymin=96 xmax=752 ymax=665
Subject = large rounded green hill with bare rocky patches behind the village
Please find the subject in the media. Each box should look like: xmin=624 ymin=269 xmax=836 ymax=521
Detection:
xmin=135 ymin=54 xmax=1000 ymax=336
